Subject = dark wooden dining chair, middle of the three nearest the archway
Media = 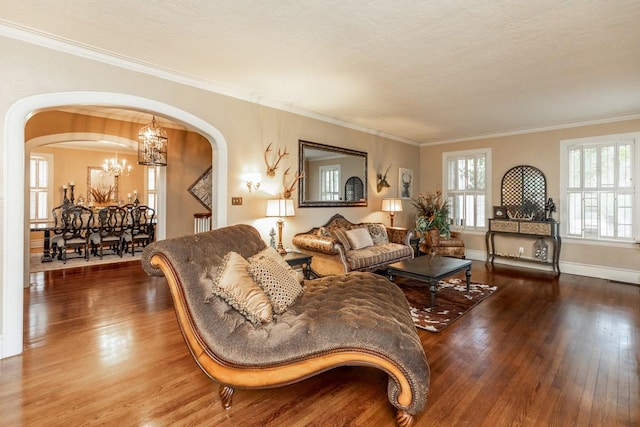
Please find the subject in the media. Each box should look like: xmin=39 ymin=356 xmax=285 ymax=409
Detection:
xmin=89 ymin=206 xmax=127 ymax=259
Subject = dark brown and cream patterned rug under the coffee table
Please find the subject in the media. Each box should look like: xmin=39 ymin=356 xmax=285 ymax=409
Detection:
xmin=395 ymin=277 xmax=498 ymax=332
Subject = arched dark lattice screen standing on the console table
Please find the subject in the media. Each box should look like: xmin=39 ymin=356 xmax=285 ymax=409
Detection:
xmin=502 ymin=165 xmax=547 ymax=221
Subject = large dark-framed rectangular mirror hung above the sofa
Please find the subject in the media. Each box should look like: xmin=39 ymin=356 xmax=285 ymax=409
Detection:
xmin=298 ymin=140 xmax=369 ymax=208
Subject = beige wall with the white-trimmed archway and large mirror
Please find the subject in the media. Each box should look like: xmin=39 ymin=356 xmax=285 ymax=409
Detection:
xmin=0 ymin=37 xmax=420 ymax=332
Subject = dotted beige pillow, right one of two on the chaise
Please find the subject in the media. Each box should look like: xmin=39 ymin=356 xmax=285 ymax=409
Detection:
xmin=248 ymin=256 xmax=304 ymax=314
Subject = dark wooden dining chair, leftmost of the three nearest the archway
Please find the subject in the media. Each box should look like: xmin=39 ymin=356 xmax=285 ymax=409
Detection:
xmin=60 ymin=206 xmax=94 ymax=264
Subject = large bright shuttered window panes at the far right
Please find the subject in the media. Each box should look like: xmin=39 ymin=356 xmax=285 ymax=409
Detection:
xmin=561 ymin=134 xmax=640 ymax=241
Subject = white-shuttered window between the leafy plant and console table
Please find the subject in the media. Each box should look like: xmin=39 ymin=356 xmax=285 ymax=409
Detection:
xmin=443 ymin=149 xmax=491 ymax=230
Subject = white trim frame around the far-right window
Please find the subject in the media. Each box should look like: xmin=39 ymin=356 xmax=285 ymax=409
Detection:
xmin=558 ymin=132 xmax=640 ymax=246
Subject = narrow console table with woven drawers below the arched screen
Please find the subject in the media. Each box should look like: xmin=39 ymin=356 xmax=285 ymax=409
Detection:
xmin=485 ymin=219 xmax=562 ymax=274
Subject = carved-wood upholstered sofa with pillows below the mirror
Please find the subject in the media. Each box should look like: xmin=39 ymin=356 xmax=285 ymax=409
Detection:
xmin=293 ymin=214 xmax=414 ymax=276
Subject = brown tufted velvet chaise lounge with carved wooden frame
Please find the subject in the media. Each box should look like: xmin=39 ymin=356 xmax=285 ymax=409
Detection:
xmin=142 ymin=225 xmax=429 ymax=426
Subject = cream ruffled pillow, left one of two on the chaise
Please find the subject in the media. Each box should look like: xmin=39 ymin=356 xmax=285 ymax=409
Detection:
xmin=211 ymin=252 xmax=273 ymax=325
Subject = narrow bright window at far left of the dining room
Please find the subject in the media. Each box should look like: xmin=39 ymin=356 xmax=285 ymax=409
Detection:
xmin=29 ymin=153 xmax=53 ymax=221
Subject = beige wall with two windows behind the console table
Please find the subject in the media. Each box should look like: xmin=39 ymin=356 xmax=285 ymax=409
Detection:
xmin=420 ymin=120 xmax=640 ymax=274
